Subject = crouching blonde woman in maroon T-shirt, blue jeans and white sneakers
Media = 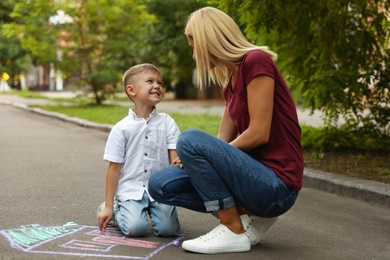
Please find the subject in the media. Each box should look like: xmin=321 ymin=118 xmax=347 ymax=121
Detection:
xmin=149 ymin=7 xmax=303 ymax=254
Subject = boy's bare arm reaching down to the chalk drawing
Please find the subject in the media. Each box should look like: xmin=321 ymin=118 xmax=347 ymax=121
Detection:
xmin=98 ymin=162 xmax=122 ymax=231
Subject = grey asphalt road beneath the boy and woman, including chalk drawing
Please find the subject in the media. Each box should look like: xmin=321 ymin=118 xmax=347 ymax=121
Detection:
xmin=0 ymin=105 xmax=390 ymax=259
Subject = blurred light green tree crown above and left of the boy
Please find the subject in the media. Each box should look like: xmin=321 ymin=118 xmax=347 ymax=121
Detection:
xmin=6 ymin=0 xmax=154 ymax=105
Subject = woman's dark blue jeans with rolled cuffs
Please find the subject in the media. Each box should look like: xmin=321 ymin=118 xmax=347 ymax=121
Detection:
xmin=149 ymin=130 xmax=298 ymax=218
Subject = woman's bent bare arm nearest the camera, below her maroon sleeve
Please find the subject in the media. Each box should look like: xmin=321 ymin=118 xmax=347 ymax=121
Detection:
xmin=231 ymin=75 xmax=275 ymax=151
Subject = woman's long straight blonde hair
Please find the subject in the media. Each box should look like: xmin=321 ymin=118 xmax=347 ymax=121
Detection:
xmin=184 ymin=7 xmax=277 ymax=89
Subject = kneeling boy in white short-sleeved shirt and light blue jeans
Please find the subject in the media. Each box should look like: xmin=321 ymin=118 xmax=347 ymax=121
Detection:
xmin=98 ymin=63 xmax=180 ymax=236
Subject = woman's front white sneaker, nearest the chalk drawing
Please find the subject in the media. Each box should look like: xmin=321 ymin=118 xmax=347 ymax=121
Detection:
xmin=181 ymin=224 xmax=251 ymax=254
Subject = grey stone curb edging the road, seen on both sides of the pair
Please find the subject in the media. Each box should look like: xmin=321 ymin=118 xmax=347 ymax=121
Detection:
xmin=0 ymin=100 xmax=390 ymax=208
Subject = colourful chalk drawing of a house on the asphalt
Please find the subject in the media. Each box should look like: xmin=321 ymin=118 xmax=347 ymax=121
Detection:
xmin=0 ymin=224 xmax=184 ymax=259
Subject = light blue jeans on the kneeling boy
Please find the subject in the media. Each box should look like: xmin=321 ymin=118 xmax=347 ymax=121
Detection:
xmin=114 ymin=192 xmax=180 ymax=237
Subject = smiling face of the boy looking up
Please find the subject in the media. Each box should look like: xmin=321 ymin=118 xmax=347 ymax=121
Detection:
xmin=126 ymin=71 xmax=163 ymax=106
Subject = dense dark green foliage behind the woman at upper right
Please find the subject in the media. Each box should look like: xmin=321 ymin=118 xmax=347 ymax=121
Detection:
xmin=219 ymin=0 xmax=390 ymax=135
